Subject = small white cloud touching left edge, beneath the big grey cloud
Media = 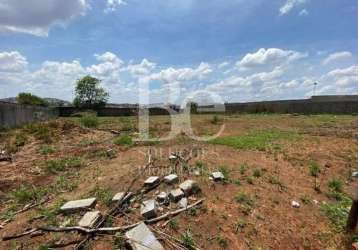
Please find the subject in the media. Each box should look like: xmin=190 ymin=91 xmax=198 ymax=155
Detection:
xmin=0 ymin=51 xmax=28 ymax=72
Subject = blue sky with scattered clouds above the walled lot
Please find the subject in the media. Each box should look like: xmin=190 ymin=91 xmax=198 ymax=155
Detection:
xmin=0 ymin=0 xmax=358 ymax=103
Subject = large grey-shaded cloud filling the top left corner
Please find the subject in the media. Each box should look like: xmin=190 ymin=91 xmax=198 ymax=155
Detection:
xmin=0 ymin=0 xmax=88 ymax=36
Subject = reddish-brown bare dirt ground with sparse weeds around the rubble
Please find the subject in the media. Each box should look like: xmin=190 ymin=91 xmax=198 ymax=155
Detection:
xmin=0 ymin=115 xmax=358 ymax=249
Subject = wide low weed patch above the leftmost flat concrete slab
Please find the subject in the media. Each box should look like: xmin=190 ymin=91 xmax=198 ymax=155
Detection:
xmin=45 ymin=157 xmax=84 ymax=174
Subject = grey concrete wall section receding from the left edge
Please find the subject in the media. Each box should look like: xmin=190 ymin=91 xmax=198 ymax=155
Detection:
xmin=0 ymin=102 xmax=58 ymax=128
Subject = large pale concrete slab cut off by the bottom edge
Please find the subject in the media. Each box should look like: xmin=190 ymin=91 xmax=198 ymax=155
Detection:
xmin=126 ymin=223 xmax=164 ymax=250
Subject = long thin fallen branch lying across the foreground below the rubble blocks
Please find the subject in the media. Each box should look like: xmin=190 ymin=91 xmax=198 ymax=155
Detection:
xmin=3 ymin=199 xmax=205 ymax=241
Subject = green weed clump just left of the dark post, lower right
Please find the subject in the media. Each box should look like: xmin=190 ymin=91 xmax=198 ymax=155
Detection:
xmin=320 ymin=194 xmax=352 ymax=231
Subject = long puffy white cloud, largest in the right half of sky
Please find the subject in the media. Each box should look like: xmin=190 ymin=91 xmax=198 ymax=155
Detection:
xmin=236 ymin=48 xmax=308 ymax=68
